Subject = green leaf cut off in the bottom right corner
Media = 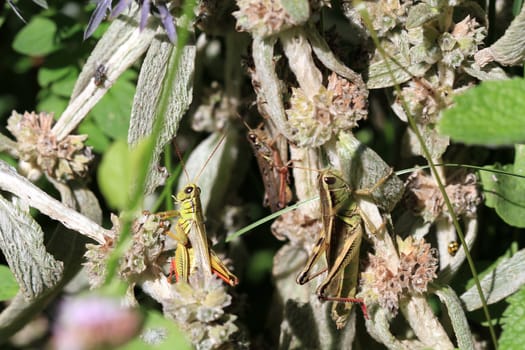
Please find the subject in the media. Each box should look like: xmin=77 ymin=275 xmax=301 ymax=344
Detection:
xmin=499 ymin=288 xmax=525 ymax=350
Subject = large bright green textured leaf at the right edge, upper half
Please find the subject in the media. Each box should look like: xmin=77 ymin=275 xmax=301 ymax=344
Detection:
xmin=439 ymin=79 xmax=525 ymax=145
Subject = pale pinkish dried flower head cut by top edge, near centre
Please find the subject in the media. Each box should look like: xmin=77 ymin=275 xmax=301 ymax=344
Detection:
xmin=233 ymin=0 xmax=297 ymax=36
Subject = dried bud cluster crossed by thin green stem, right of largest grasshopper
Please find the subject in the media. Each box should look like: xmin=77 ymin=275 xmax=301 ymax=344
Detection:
xmin=405 ymin=171 xmax=481 ymax=222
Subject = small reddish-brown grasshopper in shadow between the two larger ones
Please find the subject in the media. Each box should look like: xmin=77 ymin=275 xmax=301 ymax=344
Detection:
xmin=246 ymin=121 xmax=292 ymax=212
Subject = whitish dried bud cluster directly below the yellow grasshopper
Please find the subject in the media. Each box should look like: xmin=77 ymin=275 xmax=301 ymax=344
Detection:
xmin=163 ymin=274 xmax=242 ymax=350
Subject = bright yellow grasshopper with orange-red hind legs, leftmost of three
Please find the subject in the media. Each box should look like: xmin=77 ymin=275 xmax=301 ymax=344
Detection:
xmin=158 ymin=134 xmax=239 ymax=286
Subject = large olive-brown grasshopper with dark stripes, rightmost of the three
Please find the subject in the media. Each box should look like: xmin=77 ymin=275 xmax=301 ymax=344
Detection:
xmin=296 ymin=170 xmax=390 ymax=329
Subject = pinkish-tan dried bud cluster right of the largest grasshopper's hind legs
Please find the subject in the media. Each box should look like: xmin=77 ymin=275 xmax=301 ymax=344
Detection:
xmin=358 ymin=237 xmax=438 ymax=314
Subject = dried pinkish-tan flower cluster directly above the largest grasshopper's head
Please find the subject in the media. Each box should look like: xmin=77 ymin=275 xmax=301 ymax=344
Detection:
xmin=286 ymin=73 xmax=368 ymax=147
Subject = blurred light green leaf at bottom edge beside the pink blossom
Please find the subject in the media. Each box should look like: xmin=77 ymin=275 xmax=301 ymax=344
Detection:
xmin=119 ymin=310 xmax=193 ymax=350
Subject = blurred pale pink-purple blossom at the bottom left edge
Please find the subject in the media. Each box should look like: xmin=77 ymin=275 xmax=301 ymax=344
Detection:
xmin=52 ymin=297 xmax=142 ymax=350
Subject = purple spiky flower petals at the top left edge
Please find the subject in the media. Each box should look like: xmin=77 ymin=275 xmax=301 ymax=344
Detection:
xmin=84 ymin=0 xmax=177 ymax=43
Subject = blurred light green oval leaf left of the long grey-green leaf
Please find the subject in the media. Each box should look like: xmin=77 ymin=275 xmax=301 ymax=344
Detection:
xmin=97 ymin=141 xmax=133 ymax=209
